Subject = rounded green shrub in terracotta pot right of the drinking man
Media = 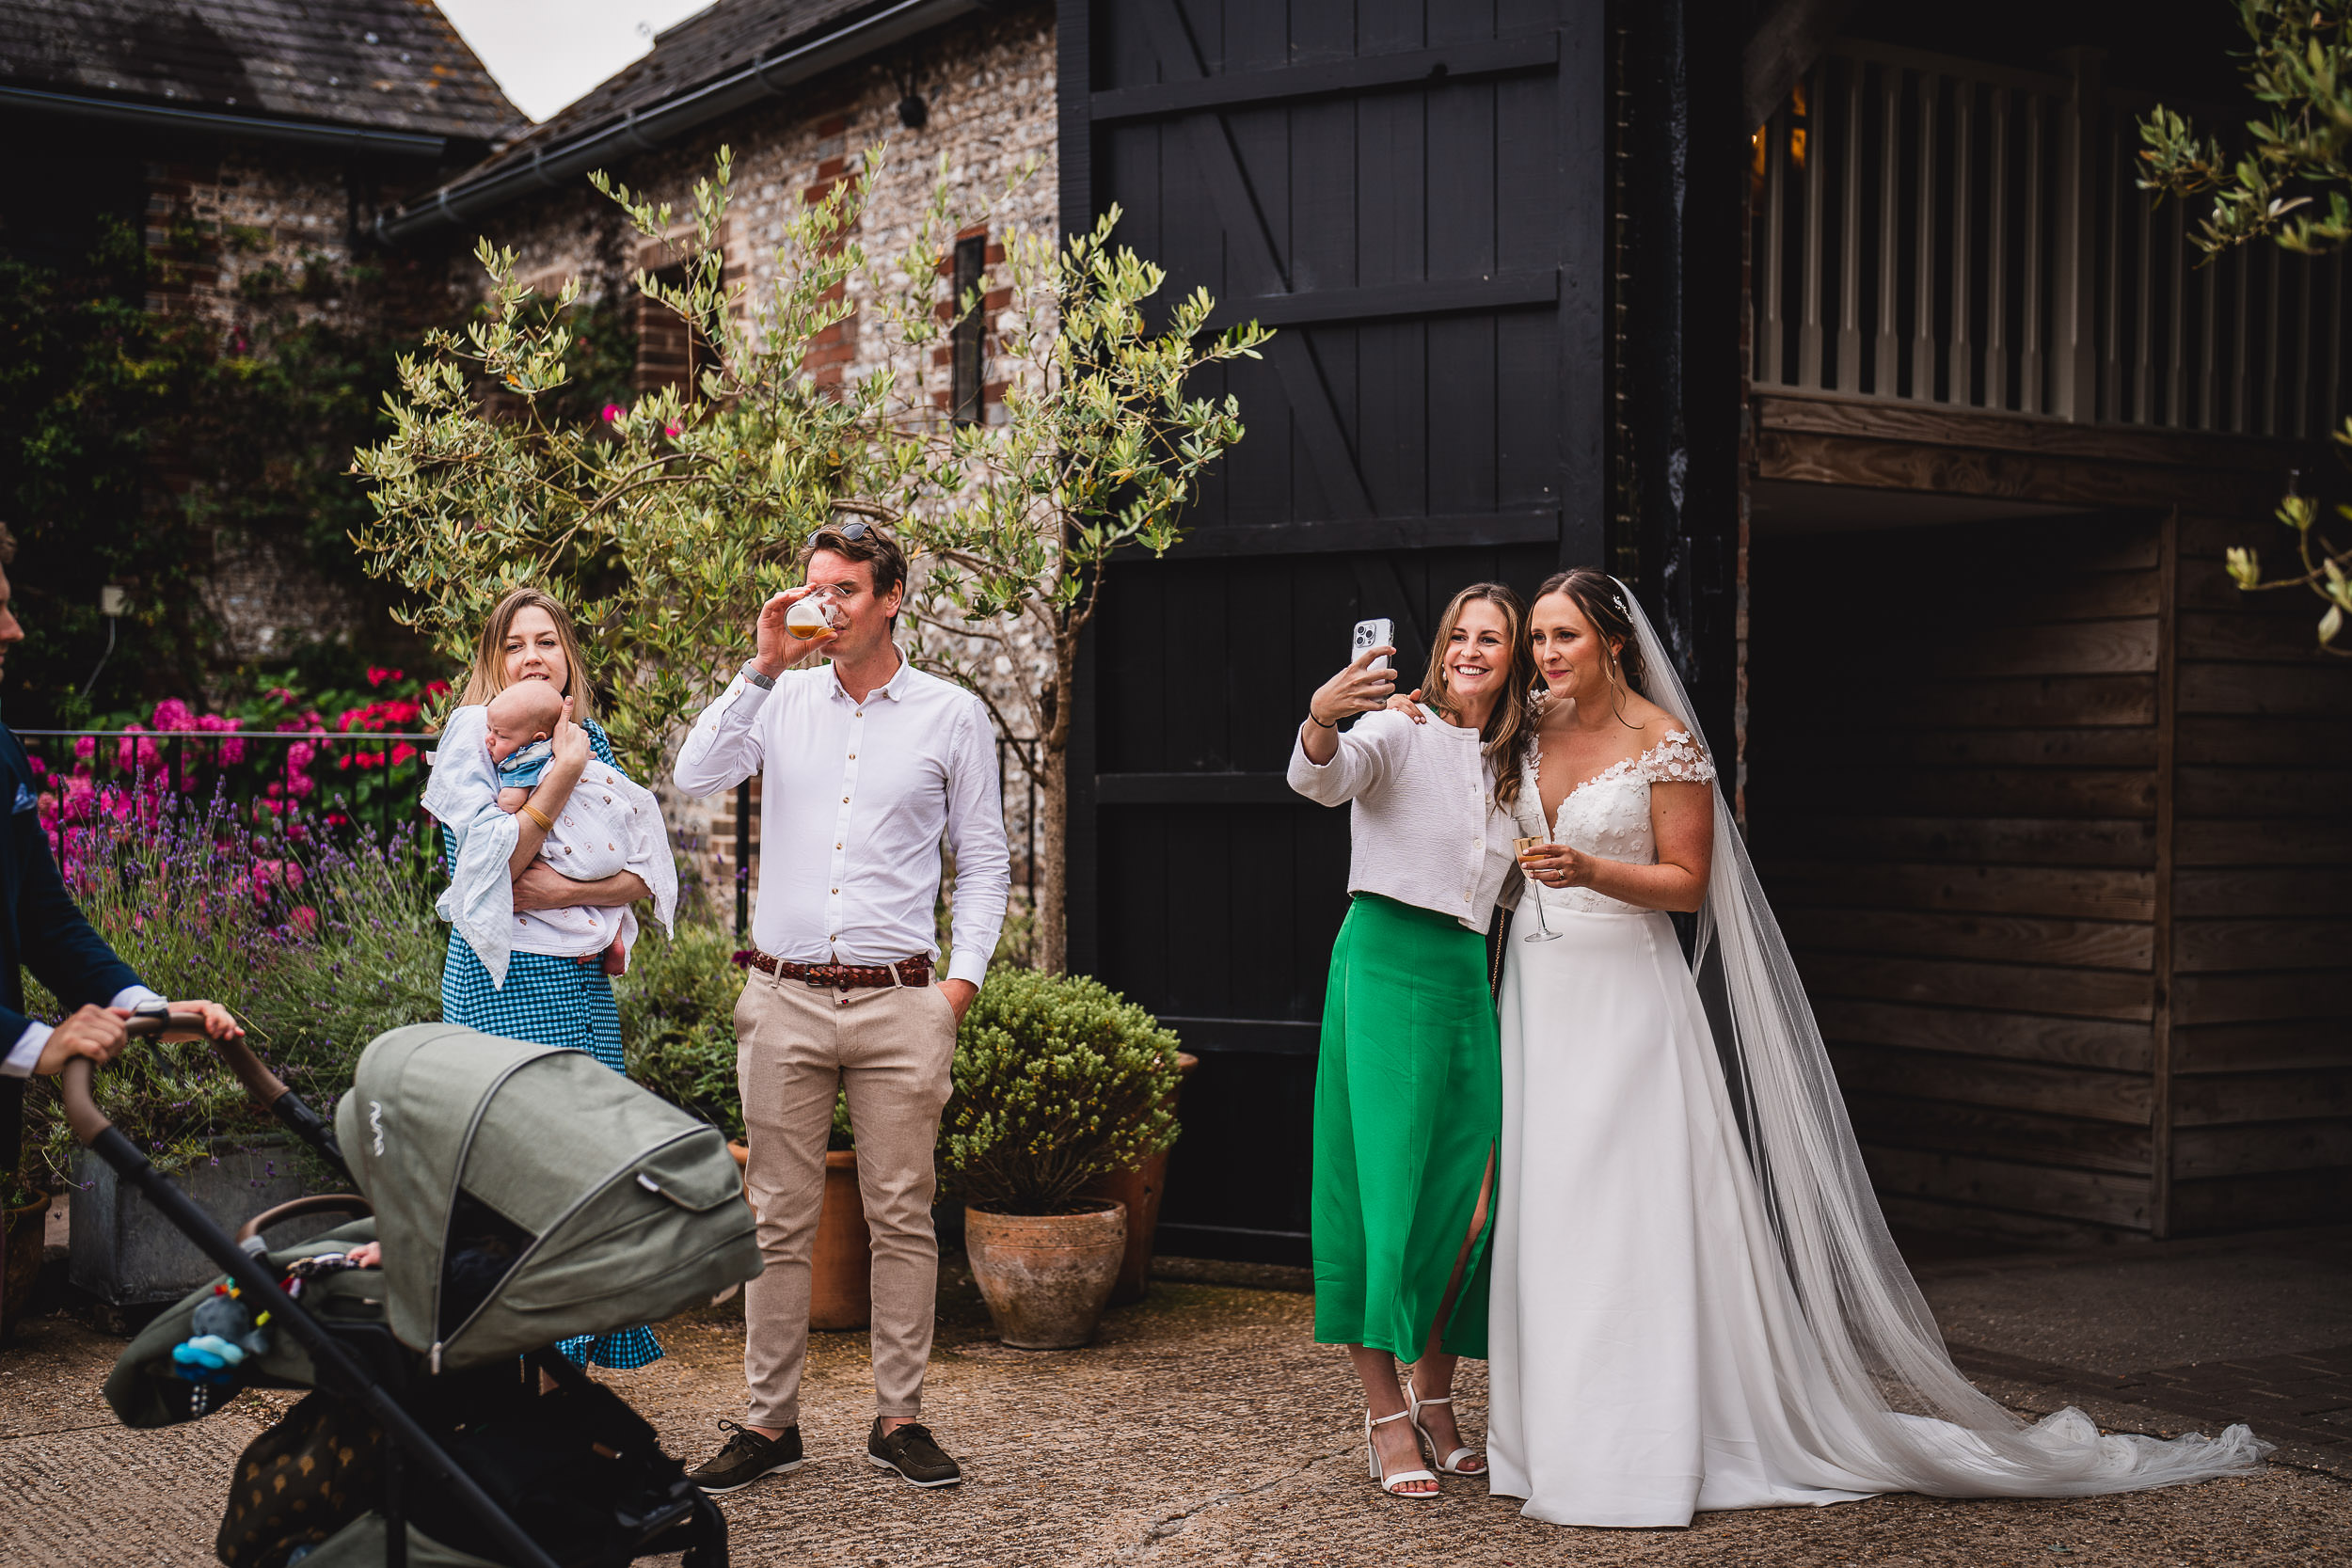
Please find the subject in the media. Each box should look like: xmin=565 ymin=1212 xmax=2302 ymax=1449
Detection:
xmin=939 ymin=966 xmax=1179 ymax=1350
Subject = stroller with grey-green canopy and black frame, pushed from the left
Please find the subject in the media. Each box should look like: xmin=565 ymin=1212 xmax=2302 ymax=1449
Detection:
xmin=64 ymin=1011 xmax=760 ymax=1568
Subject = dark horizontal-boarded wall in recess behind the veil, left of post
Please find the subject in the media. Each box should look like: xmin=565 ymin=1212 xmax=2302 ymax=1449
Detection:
xmin=1748 ymin=517 xmax=2162 ymax=1234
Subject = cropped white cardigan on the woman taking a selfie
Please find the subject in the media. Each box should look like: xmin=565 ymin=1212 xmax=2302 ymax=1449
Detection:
xmin=1289 ymin=710 xmax=1519 ymax=933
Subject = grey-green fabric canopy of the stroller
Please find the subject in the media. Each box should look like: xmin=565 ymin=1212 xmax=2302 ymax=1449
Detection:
xmin=334 ymin=1022 xmax=760 ymax=1370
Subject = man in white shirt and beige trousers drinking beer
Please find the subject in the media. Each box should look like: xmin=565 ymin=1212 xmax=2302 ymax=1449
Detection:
xmin=677 ymin=522 xmax=1009 ymax=1493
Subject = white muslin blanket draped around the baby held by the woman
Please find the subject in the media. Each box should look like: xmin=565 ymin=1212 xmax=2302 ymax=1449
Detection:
xmin=423 ymin=705 xmax=677 ymax=990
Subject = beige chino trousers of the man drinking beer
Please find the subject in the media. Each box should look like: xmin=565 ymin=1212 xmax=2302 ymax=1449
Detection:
xmin=737 ymin=969 xmax=955 ymax=1427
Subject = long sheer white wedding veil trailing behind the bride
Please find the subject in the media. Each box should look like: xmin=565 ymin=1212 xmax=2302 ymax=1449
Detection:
xmin=1612 ymin=578 xmax=2270 ymax=1497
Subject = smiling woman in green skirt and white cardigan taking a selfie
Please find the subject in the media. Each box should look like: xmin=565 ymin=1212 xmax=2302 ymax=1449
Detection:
xmin=1289 ymin=583 xmax=1532 ymax=1497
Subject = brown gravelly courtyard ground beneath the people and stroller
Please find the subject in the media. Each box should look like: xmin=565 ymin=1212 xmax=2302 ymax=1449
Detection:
xmin=0 ymin=1232 xmax=2352 ymax=1568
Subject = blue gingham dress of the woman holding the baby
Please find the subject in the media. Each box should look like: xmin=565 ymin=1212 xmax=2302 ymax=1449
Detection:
xmin=442 ymin=720 xmax=661 ymax=1370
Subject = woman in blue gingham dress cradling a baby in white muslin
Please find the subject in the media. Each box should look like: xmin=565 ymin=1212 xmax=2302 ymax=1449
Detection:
xmin=423 ymin=588 xmax=677 ymax=1369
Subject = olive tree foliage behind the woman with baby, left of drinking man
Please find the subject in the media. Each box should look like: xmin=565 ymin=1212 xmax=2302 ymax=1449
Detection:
xmin=353 ymin=148 xmax=913 ymax=778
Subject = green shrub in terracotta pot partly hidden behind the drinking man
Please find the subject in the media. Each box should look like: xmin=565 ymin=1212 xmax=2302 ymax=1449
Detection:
xmin=614 ymin=922 xmax=873 ymax=1331
